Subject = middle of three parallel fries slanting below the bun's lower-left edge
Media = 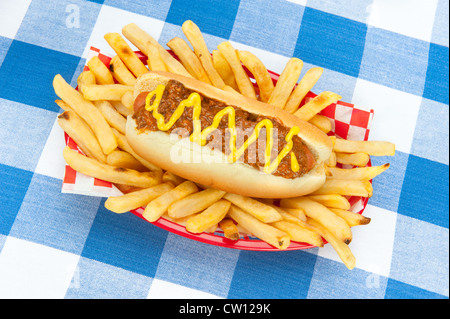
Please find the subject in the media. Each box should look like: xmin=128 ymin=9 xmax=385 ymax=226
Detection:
xmin=167 ymin=188 xmax=225 ymax=219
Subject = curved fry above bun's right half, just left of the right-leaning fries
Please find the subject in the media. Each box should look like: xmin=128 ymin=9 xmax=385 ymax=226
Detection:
xmin=237 ymin=50 xmax=275 ymax=102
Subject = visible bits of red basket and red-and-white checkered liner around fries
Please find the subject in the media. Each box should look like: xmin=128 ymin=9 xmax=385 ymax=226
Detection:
xmin=62 ymin=47 xmax=374 ymax=251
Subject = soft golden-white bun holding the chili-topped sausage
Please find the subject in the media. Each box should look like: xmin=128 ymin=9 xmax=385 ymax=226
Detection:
xmin=126 ymin=71 xmax=332 ymax=198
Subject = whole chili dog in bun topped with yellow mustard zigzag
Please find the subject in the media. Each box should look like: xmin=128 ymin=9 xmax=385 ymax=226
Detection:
xmin=126 ymin=71 xmax=332 ymax=198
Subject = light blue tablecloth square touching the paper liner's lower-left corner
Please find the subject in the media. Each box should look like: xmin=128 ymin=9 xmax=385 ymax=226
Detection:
xmin=10 ymin=173 xmax=101 ymax=255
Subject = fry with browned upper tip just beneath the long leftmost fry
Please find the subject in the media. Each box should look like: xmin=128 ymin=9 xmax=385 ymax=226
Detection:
xmin=58 ymin=110 xmax=106 ymax=163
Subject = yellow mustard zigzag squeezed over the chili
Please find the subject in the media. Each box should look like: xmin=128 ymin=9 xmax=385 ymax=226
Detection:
xmin=145 ymin=84 xmax=300 ymax=174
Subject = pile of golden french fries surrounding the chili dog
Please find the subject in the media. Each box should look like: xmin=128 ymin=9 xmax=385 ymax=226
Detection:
xmin=53 ymin=21 xmax=395 ymax=269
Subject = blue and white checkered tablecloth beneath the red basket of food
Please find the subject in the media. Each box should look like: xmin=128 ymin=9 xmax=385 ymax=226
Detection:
xmin=0 ymin=0 xmax=449 ymax=299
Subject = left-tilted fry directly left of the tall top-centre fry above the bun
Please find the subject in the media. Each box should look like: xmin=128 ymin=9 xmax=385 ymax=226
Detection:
xmin=167 ymin=37 xmax=211 ymax=84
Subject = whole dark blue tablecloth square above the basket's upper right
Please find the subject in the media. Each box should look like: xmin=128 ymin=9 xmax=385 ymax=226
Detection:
xmin=294 ymin=7 xmax=367 ymax=77
